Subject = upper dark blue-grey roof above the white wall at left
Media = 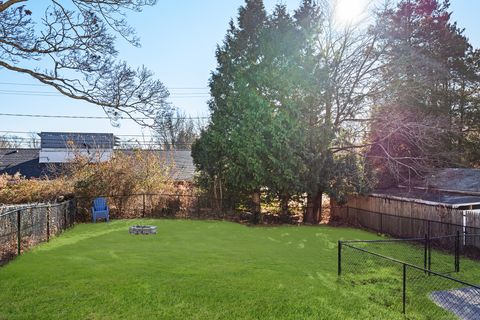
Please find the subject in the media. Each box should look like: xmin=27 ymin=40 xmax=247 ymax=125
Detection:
xmin=38 ymin=132 xmax=117 ymax=149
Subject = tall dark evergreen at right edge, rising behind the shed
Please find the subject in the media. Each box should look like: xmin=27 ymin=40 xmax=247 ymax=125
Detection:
xmin=369 ymin=0 xmax=480 ymax=183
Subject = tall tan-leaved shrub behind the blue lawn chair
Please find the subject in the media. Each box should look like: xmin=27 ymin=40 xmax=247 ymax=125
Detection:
xmin=64 ymin=151 xmax=173 ymax=219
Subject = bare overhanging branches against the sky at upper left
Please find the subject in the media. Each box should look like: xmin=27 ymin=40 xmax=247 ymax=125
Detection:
xmin=0 ymin=0 xmax=169 ymax=125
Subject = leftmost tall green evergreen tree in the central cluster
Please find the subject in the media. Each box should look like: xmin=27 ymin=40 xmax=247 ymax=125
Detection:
xmin=192 ymin=0 xmax=267 ymax=220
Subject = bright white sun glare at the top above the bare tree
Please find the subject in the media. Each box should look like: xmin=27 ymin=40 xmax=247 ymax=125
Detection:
xmin=334 ymin=0 xmax=369 ymax=26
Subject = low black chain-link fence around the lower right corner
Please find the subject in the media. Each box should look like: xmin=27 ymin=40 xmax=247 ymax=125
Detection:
xmin=338 ymin=235 xmax=480 ymax=319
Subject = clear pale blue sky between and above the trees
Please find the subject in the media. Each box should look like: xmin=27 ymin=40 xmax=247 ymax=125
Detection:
xmin=0 ymin=0 xmax=480 ymax=139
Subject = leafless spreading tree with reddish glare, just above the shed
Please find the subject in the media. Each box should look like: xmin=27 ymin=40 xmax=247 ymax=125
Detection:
xmin=366 ymin=108 xmax=459 ymax=187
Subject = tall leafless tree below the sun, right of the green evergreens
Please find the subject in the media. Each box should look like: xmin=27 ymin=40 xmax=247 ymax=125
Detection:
xmin=304 ymin=2 xmax=382 ymax=223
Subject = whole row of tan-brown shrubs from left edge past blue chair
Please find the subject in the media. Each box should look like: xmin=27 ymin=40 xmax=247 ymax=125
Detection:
xmin=0 ymin=150 xmax=173 ymax=220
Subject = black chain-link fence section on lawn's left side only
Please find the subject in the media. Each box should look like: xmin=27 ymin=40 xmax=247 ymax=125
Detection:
xmin=0 ymin=200 xmax=76 ymax=265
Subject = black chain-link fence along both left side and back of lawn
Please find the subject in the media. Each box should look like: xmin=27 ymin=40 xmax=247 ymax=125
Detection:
xmin=0 ymin=194 xmax=305 ymax=265
